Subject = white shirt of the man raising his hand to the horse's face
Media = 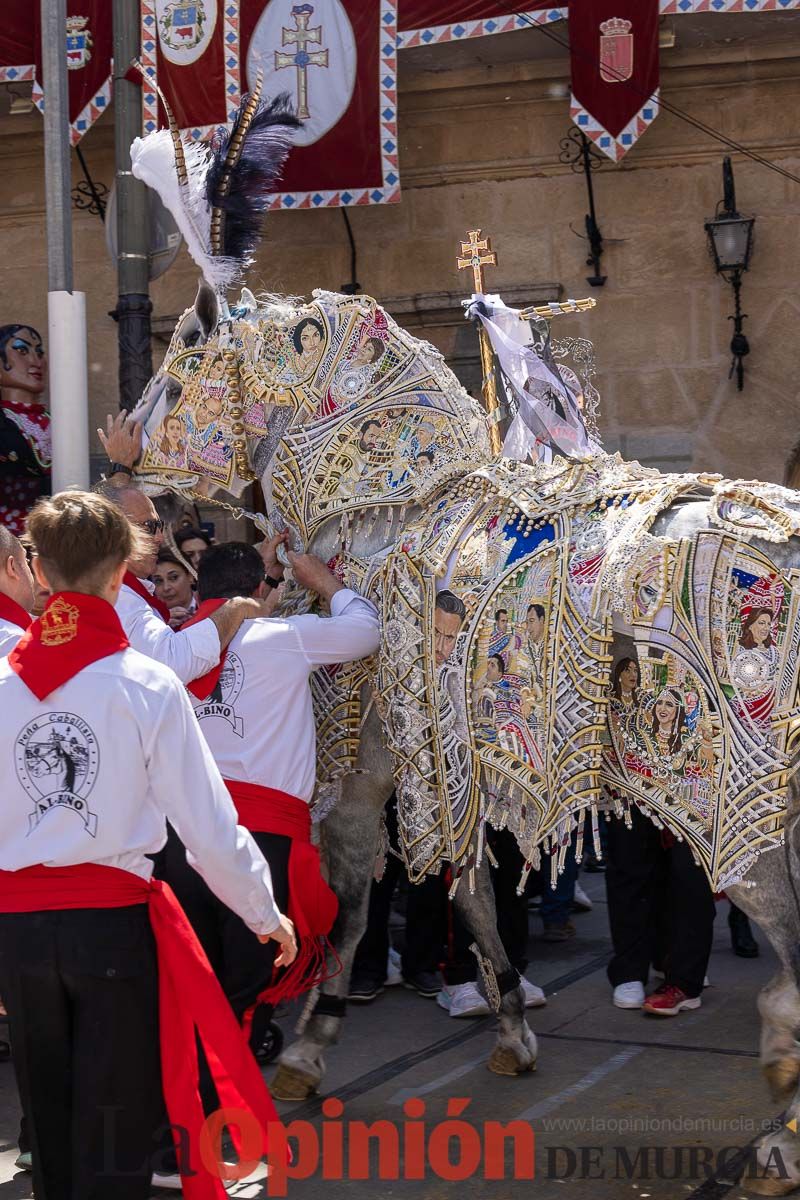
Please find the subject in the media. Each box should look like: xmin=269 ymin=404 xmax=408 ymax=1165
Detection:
xmin=116 ymin=581 xmax=219 ymax=683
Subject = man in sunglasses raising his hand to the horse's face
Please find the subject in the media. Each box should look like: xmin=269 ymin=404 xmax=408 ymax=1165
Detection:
xmin=101 ymin=487 xmax=255 ymax=683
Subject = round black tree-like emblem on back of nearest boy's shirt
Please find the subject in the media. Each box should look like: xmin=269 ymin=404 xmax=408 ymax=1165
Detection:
xmin=14 ymin=713 xmax=100 ymax=838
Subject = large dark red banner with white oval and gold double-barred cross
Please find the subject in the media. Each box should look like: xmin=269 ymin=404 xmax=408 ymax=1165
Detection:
xmin=240 ymin=0 xmax=399 ymax=209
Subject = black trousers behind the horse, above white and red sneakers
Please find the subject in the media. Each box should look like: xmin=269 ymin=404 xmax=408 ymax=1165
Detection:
xmin=606 ymin=806 xmax=716 ymax=997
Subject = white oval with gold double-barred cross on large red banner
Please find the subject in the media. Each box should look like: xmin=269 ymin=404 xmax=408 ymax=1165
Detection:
xmin=247 ymin=0 xmax=357 ymax=146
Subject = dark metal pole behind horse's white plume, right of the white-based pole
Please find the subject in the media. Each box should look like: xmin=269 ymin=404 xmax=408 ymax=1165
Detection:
xmin=110 ymin=0 xmax=152 ymax=410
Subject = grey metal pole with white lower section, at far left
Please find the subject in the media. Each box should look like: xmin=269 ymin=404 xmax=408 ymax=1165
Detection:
xmin=41 ymin=0 xmax=89 ymax=492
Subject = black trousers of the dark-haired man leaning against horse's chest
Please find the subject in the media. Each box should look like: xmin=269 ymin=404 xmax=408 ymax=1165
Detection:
xmin=155 ymin=826 xmax=291 ymax=1070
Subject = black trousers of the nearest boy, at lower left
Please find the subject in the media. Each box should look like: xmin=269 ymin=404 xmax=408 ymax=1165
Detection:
xmin=0 ymin=905 xmax=163 ymax=1200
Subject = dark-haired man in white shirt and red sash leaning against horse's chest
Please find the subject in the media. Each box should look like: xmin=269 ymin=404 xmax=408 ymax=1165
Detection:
xmin=162 ymin=542 xmax=380 ymax=1050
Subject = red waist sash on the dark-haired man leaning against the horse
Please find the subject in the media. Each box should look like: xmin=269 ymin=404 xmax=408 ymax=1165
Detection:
xmin=225 ymin=779 xmax=342 ymax=1004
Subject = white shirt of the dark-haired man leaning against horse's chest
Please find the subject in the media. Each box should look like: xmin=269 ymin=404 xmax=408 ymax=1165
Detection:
xmin=192 ymin=588 xmax=380 ymax=803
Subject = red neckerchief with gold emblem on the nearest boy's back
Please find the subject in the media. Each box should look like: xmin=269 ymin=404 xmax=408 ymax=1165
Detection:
xmin=8 ymin=592 xmax=128 ymax=700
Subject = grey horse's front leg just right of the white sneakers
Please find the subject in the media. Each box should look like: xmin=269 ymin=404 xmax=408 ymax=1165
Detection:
xmin=453 ymin=859 xmax=536 ymax=1075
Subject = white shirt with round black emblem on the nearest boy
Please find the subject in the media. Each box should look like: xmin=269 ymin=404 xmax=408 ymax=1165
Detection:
xmin=0 ymin=649 xmax=279 ymax=934
